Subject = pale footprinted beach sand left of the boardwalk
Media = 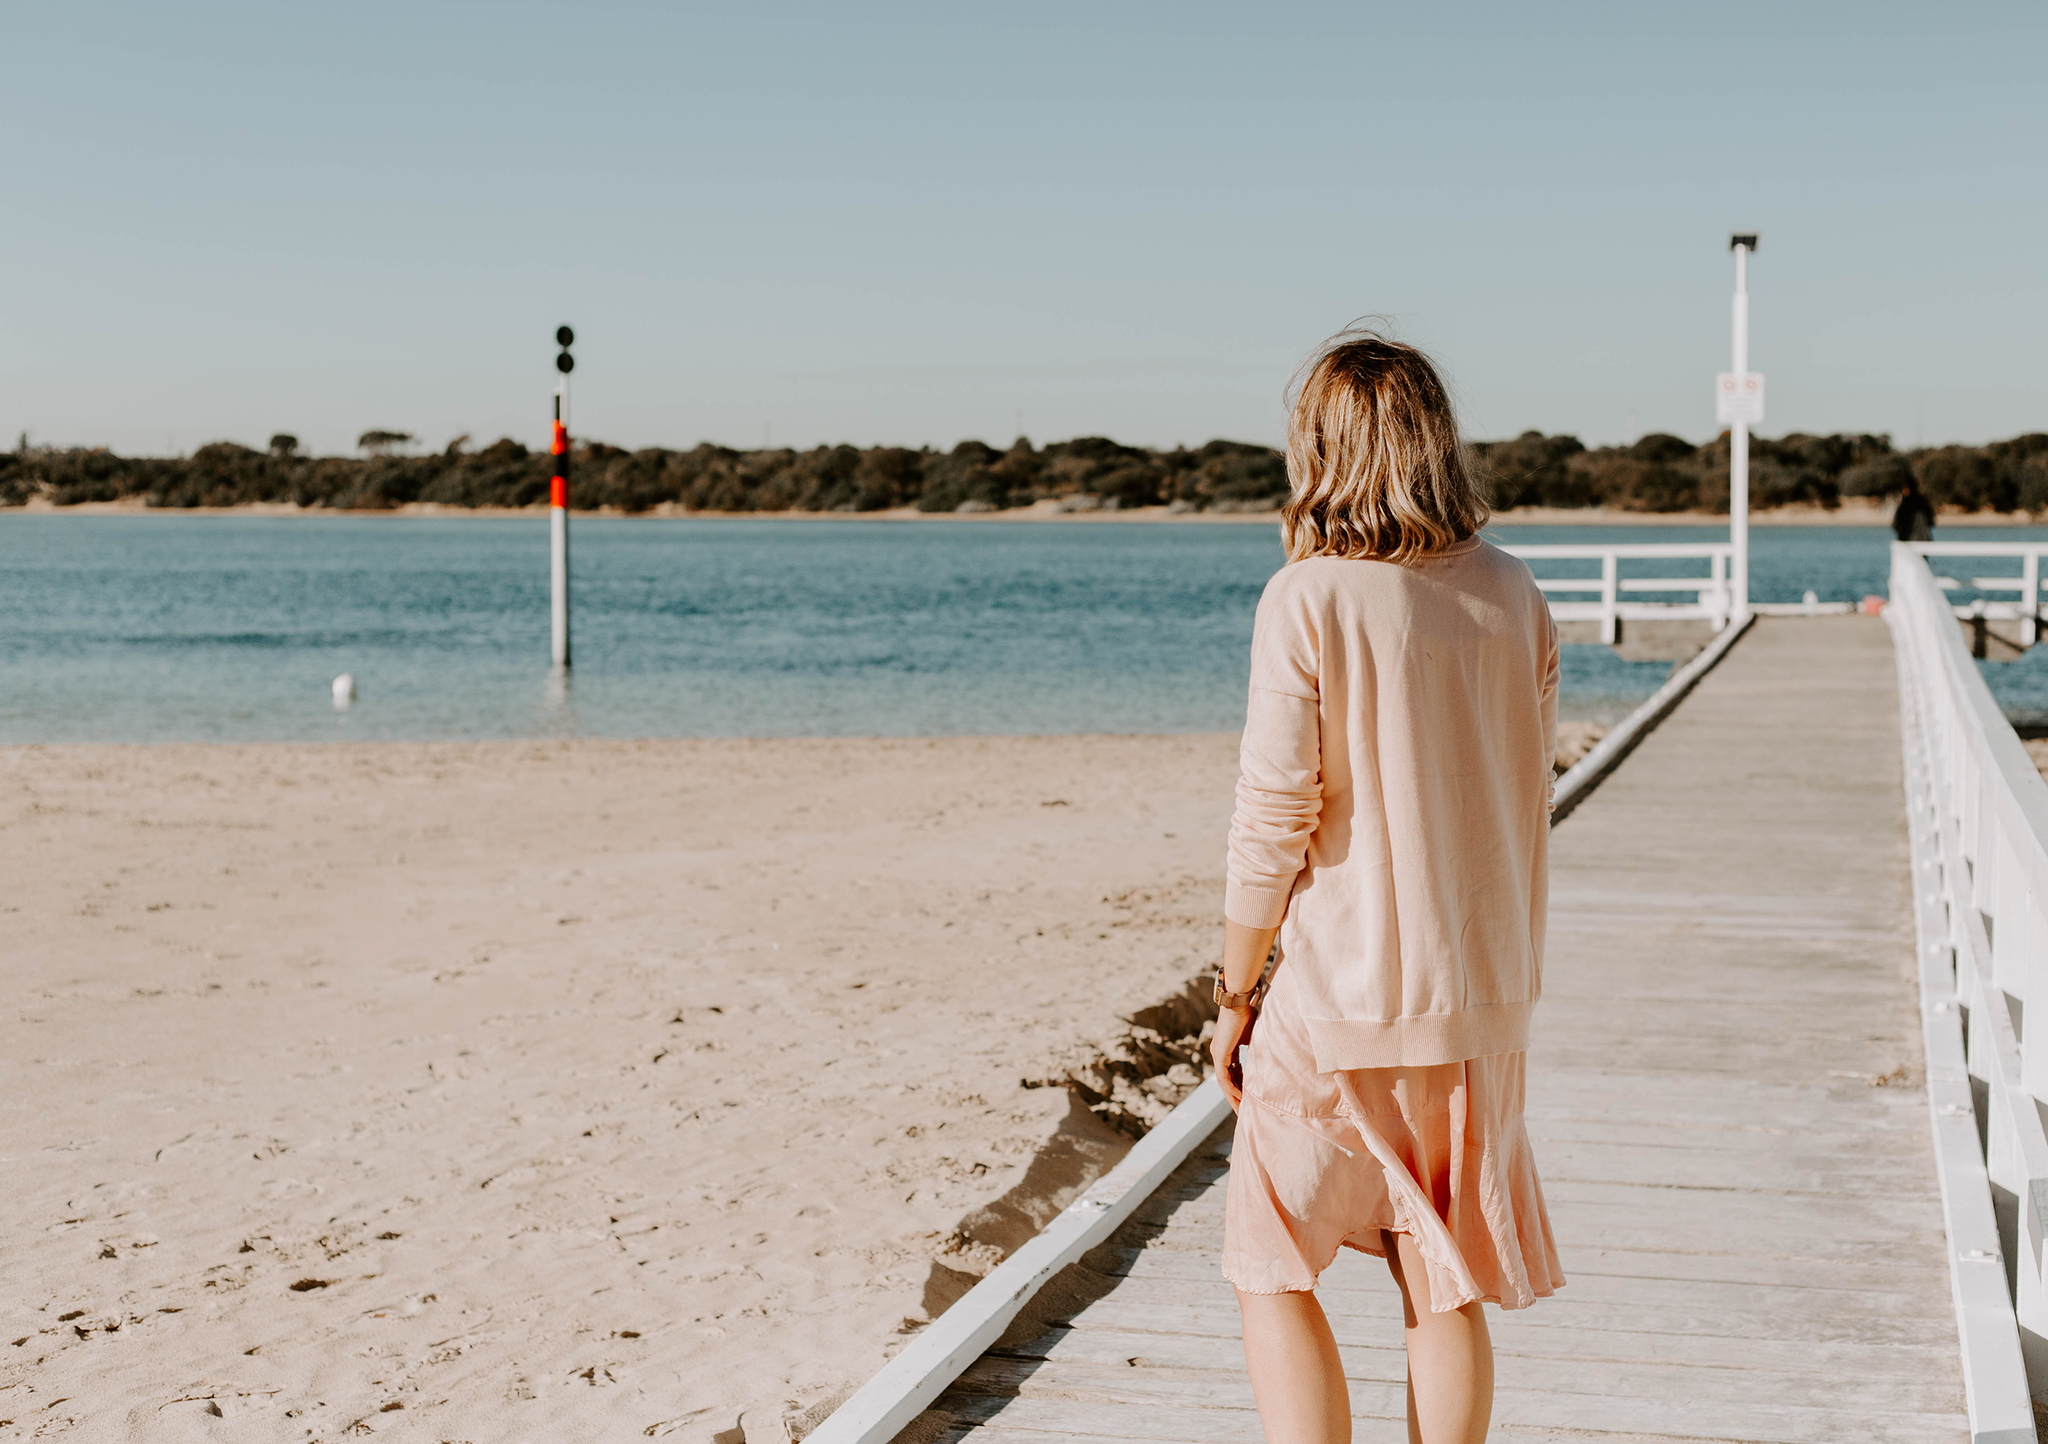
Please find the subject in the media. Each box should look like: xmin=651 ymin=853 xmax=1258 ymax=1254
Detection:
xmin=0 ymin=733 xmax=1589 ymax=1444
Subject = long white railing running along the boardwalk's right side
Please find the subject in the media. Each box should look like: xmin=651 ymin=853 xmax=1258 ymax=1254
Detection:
xmin=1884 ymin=543 xmax=2048 ymax=1440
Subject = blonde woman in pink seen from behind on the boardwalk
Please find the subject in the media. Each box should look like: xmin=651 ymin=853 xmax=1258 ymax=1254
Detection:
xmin=1214 ymin=330 xmax=1565 ymax=1444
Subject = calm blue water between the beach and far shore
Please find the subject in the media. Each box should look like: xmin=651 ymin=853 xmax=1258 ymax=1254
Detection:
xmin=0 ymin=514 xmax=2048 ymax=741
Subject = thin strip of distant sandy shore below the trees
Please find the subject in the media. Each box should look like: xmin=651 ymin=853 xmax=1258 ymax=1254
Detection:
xmin=0 ymin=498 xmax=2048 ymax=526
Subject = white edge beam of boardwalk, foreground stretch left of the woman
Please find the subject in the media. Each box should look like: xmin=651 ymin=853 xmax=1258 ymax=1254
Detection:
xmin=805 ymin=1077 xmax=1231 ymax=1444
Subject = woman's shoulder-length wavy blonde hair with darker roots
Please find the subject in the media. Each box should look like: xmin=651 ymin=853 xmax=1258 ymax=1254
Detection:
xmin=1280 ymin=326 xmax=1491 ymax=561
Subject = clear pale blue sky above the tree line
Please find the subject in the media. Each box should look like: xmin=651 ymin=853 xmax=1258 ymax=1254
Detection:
xmin=0 ymin=0 xmax=2048 ymax=453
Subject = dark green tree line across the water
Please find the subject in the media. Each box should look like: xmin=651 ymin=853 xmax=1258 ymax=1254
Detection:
xmin=0 ymin=432 xmax=2048 ymax=512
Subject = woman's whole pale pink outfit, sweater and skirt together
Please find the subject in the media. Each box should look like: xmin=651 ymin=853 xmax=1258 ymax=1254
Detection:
xmin=1223 ymin=537 xmax=1565 ymax=1311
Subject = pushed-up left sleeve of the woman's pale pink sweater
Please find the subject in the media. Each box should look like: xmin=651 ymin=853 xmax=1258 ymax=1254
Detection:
xmin=1223 ymin=586 xmax=1323 ymax=928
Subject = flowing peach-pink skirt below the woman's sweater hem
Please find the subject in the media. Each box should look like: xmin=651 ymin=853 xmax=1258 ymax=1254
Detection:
xmin=1223 ymin=963 xmax=1565 ymax=1313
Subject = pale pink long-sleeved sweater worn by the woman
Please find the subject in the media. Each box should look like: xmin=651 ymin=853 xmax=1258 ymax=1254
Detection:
xmin=1223 ymin=537 xmax=1559 ymax=1071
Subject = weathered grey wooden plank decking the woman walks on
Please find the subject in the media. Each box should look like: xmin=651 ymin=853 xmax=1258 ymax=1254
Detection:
xmin=913 ymin=617 xmax=1968 ymax=1444
